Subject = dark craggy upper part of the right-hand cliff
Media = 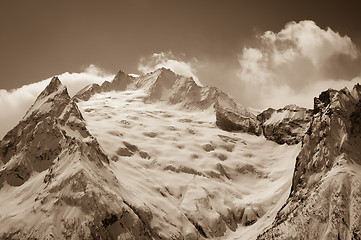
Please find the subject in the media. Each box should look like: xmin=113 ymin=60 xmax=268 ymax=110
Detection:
xmin=294 ymin=85 xmax=361 ymax=188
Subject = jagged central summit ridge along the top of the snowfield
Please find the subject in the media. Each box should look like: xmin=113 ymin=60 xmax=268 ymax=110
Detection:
xmin=74 ymin=68 xmax=262 ymax=135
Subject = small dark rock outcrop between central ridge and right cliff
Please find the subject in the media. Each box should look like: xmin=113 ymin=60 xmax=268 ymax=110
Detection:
xmin=257 ymin=105 xmax=312 ymax=144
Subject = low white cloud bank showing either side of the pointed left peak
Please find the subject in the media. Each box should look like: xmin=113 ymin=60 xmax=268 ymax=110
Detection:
xmin=0 ymin=65 xmax=114 ymax=139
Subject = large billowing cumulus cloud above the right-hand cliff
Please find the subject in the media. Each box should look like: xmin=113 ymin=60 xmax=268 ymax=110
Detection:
xmin=236 ymin=21 xmax=361 ymax=108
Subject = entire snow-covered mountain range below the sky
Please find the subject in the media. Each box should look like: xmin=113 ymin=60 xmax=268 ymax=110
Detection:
xmin=0 ymin=68 xmax=360 ymax=239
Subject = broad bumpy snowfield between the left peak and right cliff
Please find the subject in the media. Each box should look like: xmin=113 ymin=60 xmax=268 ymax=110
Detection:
xmin=78 ymin=89 xmax=300 ymax=239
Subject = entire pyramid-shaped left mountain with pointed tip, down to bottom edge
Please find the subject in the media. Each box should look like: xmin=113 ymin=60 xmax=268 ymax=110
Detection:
xmin=0 ymin=78 xmax=163 ymax=239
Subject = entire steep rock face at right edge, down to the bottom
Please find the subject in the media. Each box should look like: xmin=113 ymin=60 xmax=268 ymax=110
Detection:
xmin=258 ymin=85 xmax=361 ymax=239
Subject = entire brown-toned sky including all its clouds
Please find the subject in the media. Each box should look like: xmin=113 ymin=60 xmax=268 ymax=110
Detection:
xmin=0 ymin=0 xmax=361 ymax=137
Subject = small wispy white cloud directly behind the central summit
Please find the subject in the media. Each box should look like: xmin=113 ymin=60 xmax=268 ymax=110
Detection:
xmin=138 ymin=51 xmax=202 ymax=86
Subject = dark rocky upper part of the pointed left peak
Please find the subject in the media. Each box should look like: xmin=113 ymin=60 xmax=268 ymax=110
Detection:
xmin=0 ymin=78 xmax=107 ymax=188
